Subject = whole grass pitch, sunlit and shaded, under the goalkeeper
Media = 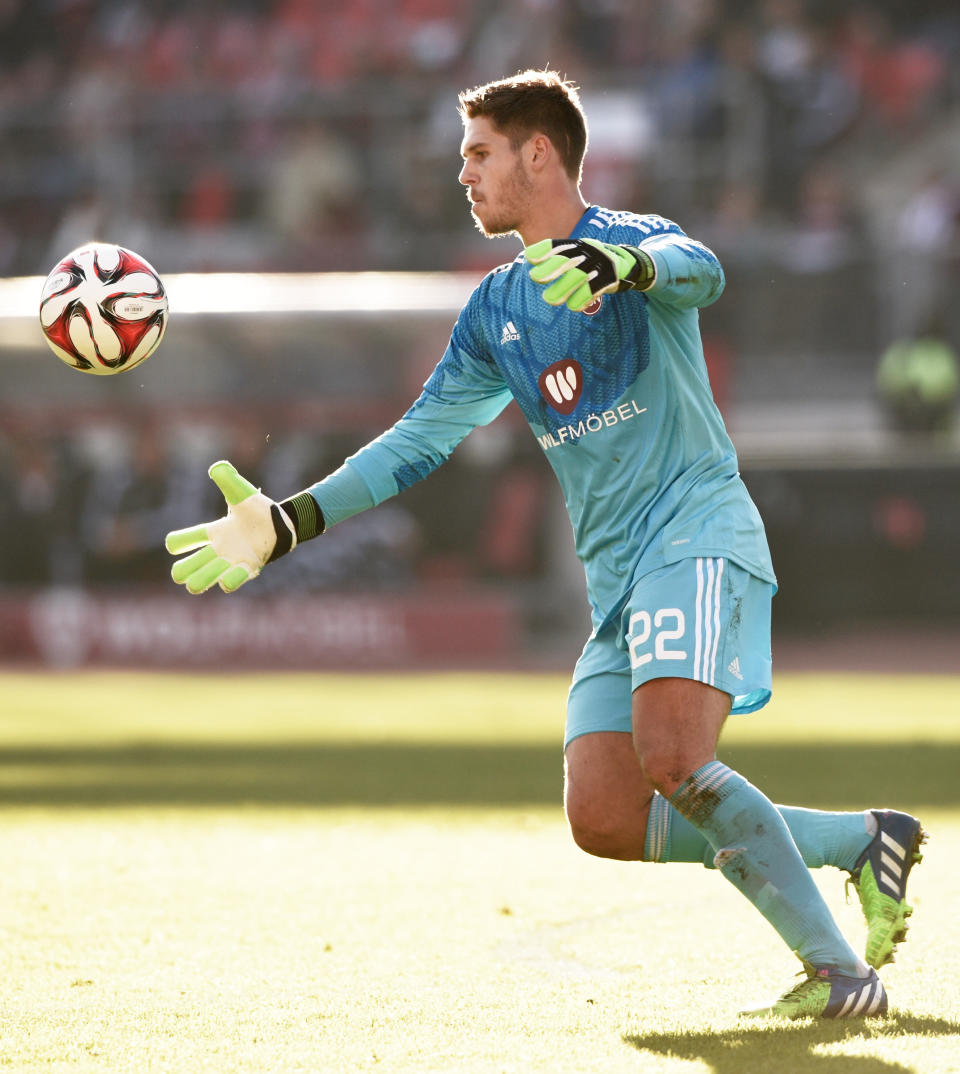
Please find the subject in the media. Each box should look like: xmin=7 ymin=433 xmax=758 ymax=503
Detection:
xmin=0 ymin=674 xmax=960 ymax=1074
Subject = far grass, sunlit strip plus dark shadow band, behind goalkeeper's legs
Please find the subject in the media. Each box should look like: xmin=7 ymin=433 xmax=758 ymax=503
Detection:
xmin=0 ymin=673 xmax=960 ymax=809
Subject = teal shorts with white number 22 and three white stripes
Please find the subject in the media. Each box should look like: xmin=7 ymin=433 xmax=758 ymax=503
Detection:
xmin=564 ymin=558 xmax=774 ymax=746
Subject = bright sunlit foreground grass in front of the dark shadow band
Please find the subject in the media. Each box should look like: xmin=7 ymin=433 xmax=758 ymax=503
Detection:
xmin=0 ymin=809 xmax=960 ymax=1074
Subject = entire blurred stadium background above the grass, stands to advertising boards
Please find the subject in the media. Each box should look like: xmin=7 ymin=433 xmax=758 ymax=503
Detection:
xmin=0 ymin=0 xmax=960 ymax=670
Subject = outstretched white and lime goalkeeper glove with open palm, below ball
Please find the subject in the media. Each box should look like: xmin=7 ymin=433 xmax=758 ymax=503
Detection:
xmin=166 ymin=461 xmax=323 ymax=593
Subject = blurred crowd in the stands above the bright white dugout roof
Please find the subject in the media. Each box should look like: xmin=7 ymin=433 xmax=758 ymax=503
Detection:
xmin=0 ymin=0 xmax=960 ymax=285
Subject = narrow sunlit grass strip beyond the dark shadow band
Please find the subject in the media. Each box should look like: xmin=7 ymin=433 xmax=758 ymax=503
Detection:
xmin=0 ymin=671 xmax=960 ymax=743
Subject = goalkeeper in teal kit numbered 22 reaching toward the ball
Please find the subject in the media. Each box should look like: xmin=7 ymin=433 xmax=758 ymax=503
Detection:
xmin=166 ymin=71 xmax=923 ymax=1018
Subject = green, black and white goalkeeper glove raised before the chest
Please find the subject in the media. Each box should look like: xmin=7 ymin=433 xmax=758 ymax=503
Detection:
xmin=523 ymin=238 xmax=656 ymax=314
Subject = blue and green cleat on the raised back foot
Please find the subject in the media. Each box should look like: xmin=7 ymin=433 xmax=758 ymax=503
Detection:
xmin=847 ymin=810 xmax=927 ymax=970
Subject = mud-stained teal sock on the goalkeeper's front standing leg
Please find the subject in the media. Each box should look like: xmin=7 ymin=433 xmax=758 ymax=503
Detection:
xmin=670 ymin=760 xmax=867 ymax=977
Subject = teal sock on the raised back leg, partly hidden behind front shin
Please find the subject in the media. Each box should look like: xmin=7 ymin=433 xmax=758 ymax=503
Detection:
xmin=643 ymin=793 xmax=876 ymax=870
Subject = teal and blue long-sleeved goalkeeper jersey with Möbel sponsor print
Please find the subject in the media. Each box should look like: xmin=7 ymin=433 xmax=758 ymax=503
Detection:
xmin=309 ymin=206 xmax=775 ymax=627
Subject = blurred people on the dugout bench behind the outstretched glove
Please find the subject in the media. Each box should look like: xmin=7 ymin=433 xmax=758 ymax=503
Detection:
xmin=0 ymin=410 xmax=551 ymax=596
